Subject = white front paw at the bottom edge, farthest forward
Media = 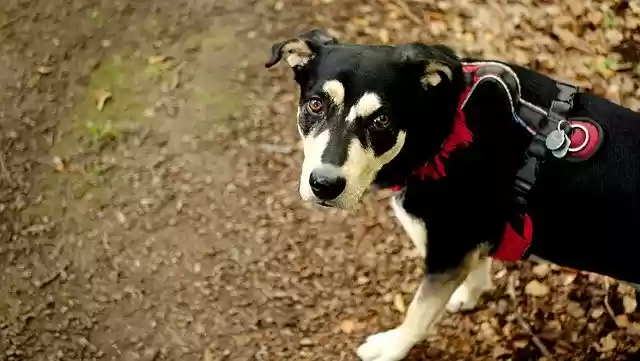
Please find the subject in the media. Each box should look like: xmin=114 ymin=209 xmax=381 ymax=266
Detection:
xmin=356 ymin=328 xmax=413 ymax=361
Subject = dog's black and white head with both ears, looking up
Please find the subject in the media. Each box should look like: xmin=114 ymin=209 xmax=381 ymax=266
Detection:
xmin=265 ymin=30 xmax=461 ymax=208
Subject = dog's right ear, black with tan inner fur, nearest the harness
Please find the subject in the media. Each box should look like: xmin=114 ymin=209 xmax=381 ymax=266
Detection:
xmin=395 ymin=43 xmax=462 ymax=88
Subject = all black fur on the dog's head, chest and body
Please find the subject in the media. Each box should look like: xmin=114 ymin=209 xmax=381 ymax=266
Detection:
xmin=271 ymin=30 xmax=640 ymax=283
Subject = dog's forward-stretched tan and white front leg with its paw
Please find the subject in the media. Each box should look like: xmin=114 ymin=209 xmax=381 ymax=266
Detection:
xmin=357 ymin=251 xmax=480 ymax=361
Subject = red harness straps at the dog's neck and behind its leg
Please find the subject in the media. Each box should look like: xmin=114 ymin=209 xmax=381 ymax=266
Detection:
xmin=392 ymin=65 xmax=533 ymax=261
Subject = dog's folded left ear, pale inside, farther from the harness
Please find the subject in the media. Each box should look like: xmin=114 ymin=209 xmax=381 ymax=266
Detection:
xmin=264 ymin=29 xmax=338 ymax=70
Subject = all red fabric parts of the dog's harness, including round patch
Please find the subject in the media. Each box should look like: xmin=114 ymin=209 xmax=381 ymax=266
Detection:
xmin=392 ymin=64 xmax=599 ymax=261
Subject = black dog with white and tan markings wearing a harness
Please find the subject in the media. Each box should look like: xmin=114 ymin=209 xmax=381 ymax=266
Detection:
xmin=265 ymin=30 xmax=640 ymax=361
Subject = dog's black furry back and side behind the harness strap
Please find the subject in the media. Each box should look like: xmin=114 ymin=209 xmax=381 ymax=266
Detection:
xmin=504 ymin=66 xmax=640 ymax=283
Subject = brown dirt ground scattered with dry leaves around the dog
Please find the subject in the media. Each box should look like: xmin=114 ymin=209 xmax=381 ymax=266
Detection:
xmin=0 ymin=0 xmax=640 ymax=361
